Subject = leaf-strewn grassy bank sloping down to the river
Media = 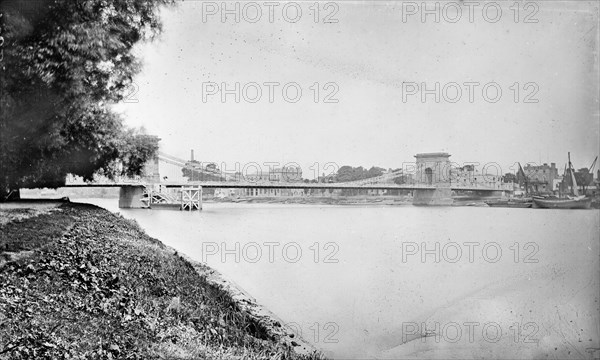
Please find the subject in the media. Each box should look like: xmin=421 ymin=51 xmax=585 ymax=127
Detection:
xmin=0 ymin=203 xmax=319 ymax=359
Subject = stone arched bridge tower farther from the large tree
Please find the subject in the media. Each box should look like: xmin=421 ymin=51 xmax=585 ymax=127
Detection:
xmin=413 ymin=152 xmax=452 ymax=205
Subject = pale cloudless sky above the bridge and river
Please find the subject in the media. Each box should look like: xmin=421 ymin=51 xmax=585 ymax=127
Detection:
xmin=116 ymin=1 xmax=600 ymax=178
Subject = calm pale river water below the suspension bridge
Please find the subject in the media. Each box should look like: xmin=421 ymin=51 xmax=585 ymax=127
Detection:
xmin=81 ymin=199 xmax=600 ymax=358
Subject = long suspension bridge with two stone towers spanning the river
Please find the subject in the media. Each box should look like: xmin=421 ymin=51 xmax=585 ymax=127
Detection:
xmin=65 ymin=152 xmax=513 ymax=209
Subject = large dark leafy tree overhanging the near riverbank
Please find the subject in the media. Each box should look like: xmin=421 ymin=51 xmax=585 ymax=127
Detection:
xmin=0 ymin=0 xmax=172 ymax=201
